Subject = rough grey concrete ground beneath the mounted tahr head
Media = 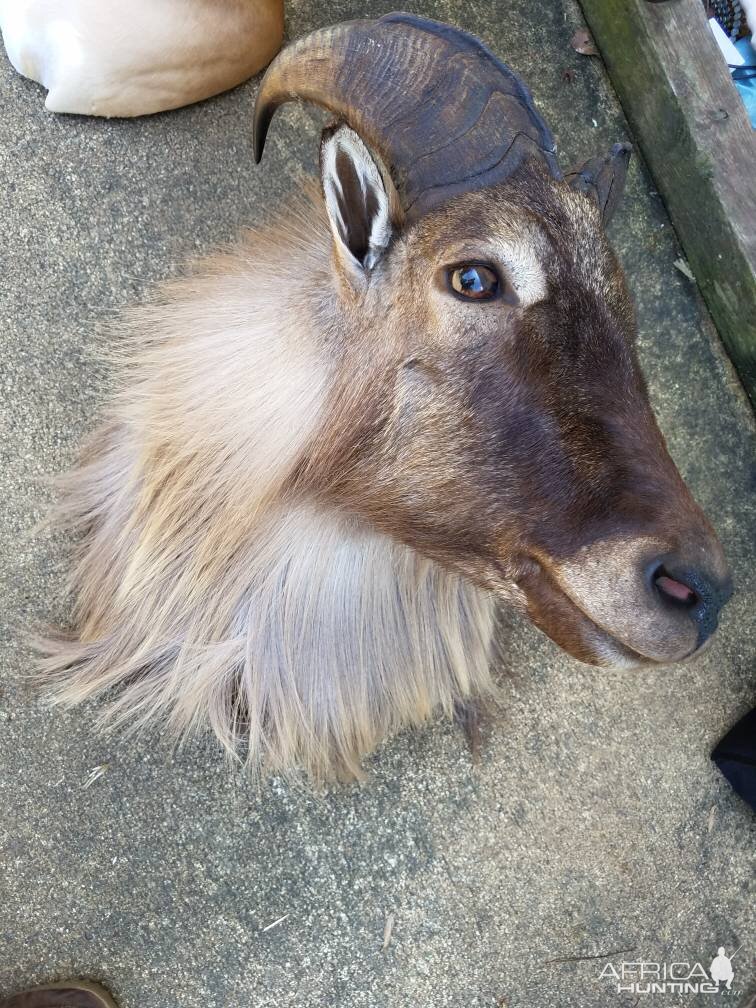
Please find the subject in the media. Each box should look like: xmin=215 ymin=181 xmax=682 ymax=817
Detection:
xmin=0 ymin=0 xmax=756 ymax=1008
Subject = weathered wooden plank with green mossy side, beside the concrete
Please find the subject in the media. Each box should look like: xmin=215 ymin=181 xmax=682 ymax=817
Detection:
xmin=582 ymin=0 xmax=756 ymax=407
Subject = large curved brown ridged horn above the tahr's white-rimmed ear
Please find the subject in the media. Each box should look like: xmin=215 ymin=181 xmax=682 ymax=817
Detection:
xmin=254 ymin=13 xmax=561 ymax=218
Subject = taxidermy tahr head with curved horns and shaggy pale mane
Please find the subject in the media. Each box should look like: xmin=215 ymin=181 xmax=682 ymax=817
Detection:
xmin=45 ymin=14 xmax=731 ymax=776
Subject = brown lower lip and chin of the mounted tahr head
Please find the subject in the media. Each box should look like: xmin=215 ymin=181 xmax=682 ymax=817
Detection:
xmin=515 ymin=560 xmax=698 ymax=668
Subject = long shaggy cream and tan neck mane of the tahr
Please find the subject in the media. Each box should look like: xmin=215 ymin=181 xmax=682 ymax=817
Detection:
xmin=37 ymin=185 xmax=494 ymax=778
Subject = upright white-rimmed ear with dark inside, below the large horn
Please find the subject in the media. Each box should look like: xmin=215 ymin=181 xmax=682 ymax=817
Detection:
xmin=321 ymin=125 xmax=398 ymax=282
